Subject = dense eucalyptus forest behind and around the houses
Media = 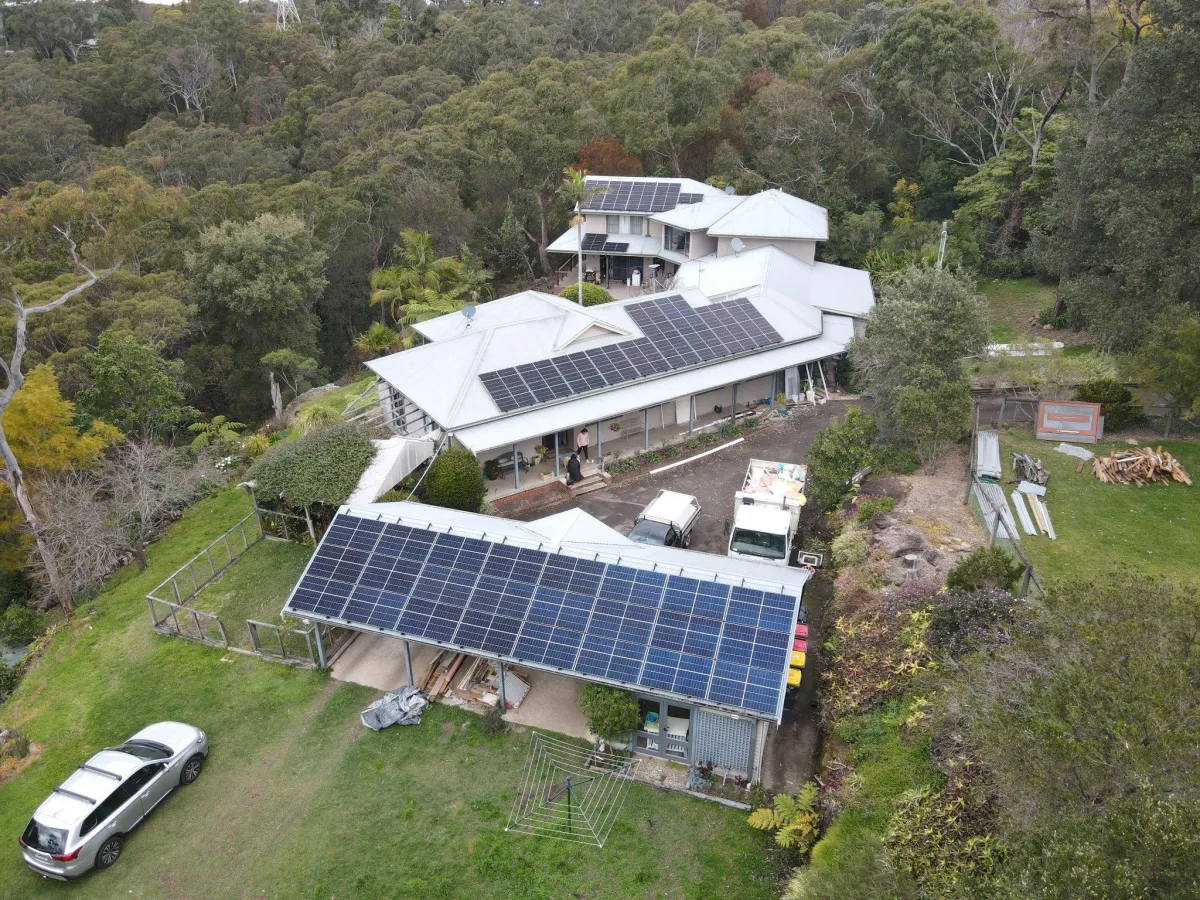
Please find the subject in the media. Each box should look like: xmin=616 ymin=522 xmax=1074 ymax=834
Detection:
xmin=0 ymin=0 xmax=1200 ymax=431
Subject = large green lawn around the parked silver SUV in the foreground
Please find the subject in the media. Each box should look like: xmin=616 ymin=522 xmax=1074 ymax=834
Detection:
xmin=0 ymin=490 xmax=781 ymax=900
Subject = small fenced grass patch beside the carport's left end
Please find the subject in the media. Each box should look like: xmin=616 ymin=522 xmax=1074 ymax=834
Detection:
xmin=191 ymin=540 xmax=312 ymax=649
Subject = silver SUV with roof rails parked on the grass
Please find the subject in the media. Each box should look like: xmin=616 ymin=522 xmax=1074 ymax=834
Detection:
xmin=20 ymin=722 xmax=209 ymax=881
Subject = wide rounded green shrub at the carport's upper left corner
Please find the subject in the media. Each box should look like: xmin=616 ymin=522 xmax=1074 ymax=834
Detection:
xmin=246 ymin=422 xmax=376 ymax=509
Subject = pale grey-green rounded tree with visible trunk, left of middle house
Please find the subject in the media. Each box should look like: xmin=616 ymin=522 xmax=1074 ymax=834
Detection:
xmin=186 ymin=212 xmax=326 ymax=414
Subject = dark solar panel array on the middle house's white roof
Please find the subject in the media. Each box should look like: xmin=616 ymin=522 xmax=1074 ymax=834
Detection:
xmin=479 ymin=294 xmax=784 ymax=413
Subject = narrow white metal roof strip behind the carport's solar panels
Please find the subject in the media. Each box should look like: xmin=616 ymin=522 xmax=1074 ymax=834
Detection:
xmin=337 ymin=502 xmax=808 ymax=596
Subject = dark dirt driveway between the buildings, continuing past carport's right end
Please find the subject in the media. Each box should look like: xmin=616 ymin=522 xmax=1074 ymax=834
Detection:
xmin=518 ymin=400 xmax=860 ymax=793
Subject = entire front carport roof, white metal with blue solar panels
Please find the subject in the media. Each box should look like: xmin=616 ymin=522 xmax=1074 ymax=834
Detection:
xmin=284 ymin=503 xmax=808 ymax=721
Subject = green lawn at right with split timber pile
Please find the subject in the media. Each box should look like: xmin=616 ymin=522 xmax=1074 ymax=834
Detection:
xmin=1000 ymin=431 xmax=1200 ymax=587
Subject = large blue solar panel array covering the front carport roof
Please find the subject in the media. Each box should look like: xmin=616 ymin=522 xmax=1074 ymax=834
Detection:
xmin=284 ymin=512 xmax=803 ymax=716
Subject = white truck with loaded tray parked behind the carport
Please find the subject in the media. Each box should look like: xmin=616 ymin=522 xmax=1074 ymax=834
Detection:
xmin=728 ymin=460 xmax=808 ymax=565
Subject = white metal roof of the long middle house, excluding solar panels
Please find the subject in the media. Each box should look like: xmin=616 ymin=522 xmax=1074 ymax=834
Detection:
xmin=367 ymin=247 xmax=874 ymax=451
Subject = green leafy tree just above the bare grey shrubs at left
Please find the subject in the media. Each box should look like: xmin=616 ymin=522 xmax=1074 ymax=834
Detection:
xmin=76 ymin=329 xmax=199 ymax=438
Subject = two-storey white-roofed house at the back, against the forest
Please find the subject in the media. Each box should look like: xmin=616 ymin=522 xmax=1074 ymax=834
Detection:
xmin=548 ymin=175 xmax=829 ymax=295
